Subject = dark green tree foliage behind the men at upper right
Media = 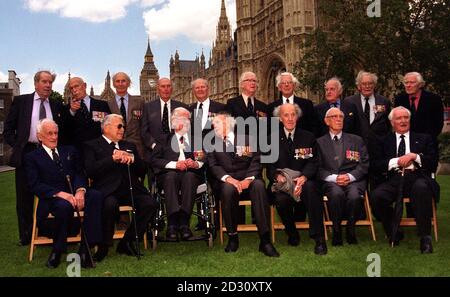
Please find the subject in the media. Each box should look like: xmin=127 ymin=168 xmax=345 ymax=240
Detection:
xmin=295 ymin=0 xmax=450 ymax=99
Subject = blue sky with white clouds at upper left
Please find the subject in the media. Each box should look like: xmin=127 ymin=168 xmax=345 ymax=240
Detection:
xmin=0 ymin=0 xmax=236 ymax=94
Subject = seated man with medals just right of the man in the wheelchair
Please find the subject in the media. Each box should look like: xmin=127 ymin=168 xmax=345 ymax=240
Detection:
xmin=207 ymin=113 xmax=280 ymax=257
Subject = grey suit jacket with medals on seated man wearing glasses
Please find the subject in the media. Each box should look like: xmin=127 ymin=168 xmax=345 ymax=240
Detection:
xmin=317 ymin=133 xmax=369 ymax=181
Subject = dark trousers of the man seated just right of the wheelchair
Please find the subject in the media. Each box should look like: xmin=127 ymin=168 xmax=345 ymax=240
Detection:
xmin=220 ymin=179 xmax=270 ymax=236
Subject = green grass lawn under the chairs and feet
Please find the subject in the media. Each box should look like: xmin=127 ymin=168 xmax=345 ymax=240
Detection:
xmin=0 ymin=172 xmax=450 ymax=277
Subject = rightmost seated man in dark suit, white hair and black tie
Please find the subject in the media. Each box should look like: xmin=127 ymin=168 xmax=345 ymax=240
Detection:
xmin=371 ymin=106 xmax=439 ymax=253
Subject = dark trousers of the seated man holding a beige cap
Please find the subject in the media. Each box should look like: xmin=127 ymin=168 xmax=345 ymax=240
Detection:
xmin=275 ymin=180 xmax=324 ymax=239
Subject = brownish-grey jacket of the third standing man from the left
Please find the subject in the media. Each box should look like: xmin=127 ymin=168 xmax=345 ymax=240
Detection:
xmin=108 ymin=94 xmax=144 ymax=159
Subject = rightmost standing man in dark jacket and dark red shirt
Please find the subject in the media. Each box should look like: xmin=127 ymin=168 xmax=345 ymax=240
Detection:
xmin=394 ymin=72 xmax=444 ymax=172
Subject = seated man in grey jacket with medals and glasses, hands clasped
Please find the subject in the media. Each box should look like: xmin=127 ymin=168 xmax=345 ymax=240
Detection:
xmin=317 ymin=107 xmax=369 ymax=246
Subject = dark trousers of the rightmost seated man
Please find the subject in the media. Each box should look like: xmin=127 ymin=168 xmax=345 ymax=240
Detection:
xmin=372 ymin=172 xmax=432 ymax=237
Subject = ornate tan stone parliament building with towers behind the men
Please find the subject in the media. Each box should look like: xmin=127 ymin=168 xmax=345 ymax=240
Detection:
xmin=80 ymin=0 xmax=318 ymax=104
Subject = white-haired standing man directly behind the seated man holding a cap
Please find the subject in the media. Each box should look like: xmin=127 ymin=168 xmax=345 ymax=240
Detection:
xmin=267 ymin=72 xmax=320 ymax=135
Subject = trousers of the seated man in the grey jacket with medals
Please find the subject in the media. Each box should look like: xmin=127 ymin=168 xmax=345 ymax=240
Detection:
xmin=323 ymin=181 xmax=366 ymax=226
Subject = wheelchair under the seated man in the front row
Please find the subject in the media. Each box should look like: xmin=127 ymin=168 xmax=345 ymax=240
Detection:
xmin=148 ymin=170 xmax=216 ymax=250
